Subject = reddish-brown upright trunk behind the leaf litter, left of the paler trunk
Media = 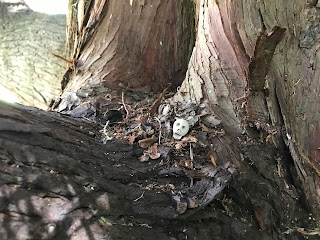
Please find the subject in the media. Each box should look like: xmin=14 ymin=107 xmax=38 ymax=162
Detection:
xmin=62 ymin=0 xmax=194 ymax=92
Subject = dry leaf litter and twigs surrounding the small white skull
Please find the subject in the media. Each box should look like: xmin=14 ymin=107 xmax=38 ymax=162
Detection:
xmin=56 ymin=87 xmax=236 ymax=215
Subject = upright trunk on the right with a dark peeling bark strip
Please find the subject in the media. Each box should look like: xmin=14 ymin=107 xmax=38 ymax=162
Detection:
xmin=176 ymin=0 xmax=320 ymax=219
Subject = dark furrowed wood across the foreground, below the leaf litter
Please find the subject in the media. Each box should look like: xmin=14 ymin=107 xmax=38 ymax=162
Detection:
xmin=0 ymin=103 xmax=316 ymax=239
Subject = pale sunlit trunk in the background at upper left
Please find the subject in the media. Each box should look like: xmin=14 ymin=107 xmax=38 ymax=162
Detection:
xmin=0 ymin=3 xmax=66 ymax=109
